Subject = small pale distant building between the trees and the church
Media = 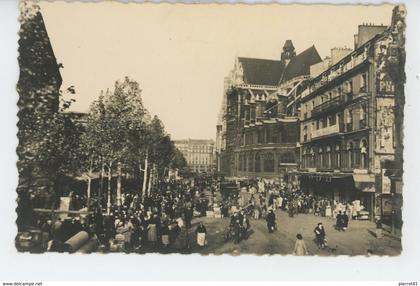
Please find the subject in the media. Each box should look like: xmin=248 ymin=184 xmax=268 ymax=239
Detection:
xmin=174 ymin=139 xmax=215 ymax=173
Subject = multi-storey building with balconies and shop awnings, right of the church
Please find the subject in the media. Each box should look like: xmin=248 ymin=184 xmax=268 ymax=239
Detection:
xmin=297 ymin=7 xmax=405 ymax=218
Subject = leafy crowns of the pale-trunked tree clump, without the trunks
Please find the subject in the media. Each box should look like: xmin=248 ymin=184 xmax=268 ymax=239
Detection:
xmin=74 ymin=77 xmax=180 ymax=198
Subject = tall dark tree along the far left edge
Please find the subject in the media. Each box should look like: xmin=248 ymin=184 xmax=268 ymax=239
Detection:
xmin=16 ymin=1 xmax=75 ymax=210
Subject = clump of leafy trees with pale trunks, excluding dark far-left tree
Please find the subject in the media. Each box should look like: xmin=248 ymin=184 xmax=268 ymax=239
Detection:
xmin=68 ymin=77 xmax=186 ymax=209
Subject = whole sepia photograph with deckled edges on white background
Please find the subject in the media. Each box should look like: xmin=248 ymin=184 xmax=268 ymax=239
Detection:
xmin=14 ymin=0 xmax=407 ymax=259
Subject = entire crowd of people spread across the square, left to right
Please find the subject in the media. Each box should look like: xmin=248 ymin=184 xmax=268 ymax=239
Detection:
xmin=18 ymin=179 xmax=374 ymax=255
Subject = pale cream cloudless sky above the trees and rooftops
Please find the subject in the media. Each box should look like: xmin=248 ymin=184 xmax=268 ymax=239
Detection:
xmin=40 ymin=1 xmax=392 ymax=139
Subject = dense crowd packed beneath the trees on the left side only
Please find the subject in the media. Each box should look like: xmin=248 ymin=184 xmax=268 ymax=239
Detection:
xmin=29 ymin=180 xmax=217 ymax=252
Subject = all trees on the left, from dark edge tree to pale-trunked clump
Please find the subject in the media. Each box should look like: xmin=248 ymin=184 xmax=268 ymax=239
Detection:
xmin=16 ymin=1 xmax=186 ymax=227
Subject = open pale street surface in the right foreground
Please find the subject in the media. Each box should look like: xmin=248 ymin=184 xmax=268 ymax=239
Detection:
xmin=182 ymin=210 xmax=401 ymax=256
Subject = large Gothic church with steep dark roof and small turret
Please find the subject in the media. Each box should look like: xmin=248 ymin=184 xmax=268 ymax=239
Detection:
xmin=216 ymin=40 xmax=321 ymax=178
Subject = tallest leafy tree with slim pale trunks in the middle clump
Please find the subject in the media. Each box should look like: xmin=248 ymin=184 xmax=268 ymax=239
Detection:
xmin=83 ymin=78 xmax=148 ymax=211
